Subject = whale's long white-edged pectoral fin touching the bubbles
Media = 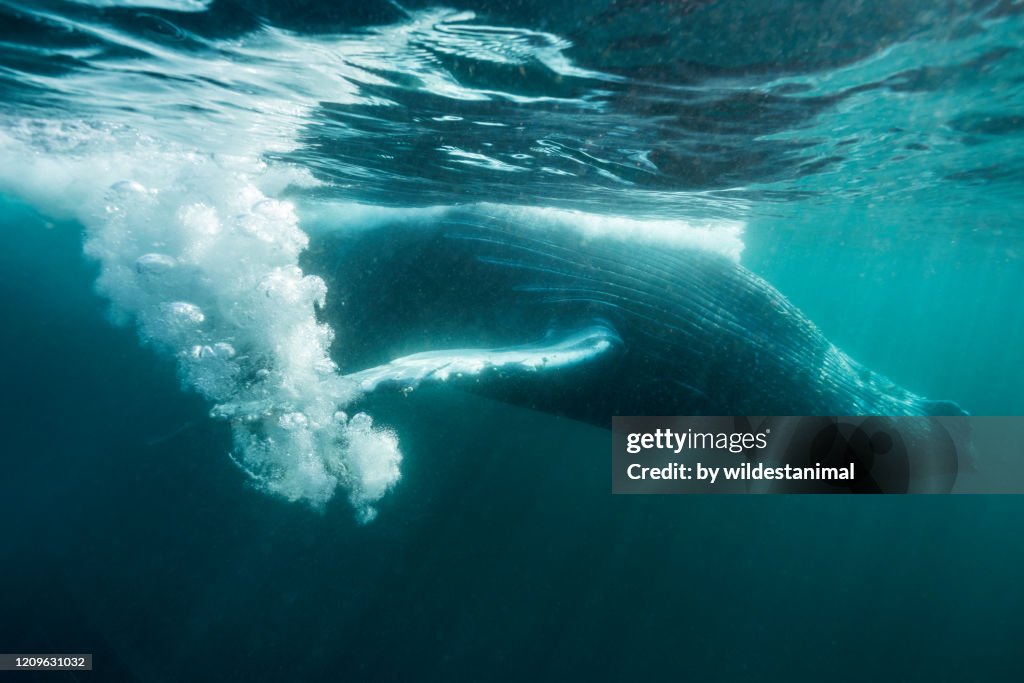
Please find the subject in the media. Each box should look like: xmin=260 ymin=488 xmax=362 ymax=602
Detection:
xmin=346 ymin=326 xmax=623 ymax=392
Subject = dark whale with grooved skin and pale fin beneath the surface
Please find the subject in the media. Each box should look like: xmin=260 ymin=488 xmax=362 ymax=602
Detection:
xmin=304 ymin=211 xmax=966 ymax=427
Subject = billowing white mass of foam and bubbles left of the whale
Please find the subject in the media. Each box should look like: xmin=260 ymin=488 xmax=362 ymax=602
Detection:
xmin=0 ymin=121 xmax=401 ymax=520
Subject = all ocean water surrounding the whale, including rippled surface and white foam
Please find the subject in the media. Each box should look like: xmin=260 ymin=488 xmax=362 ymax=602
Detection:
xmin=0 ymin=0 xmax=1024 ymax=681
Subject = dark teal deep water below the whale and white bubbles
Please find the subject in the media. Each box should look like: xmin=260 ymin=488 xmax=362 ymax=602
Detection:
xmin=0 ymin=196 xmax=1024 ymax=681
